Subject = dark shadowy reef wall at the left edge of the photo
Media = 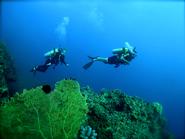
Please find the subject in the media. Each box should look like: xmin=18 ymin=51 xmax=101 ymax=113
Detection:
xmin=0 ymin=42 xmax=16 ymax=98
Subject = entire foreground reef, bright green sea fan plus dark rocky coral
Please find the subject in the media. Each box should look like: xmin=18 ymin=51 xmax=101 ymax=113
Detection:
xmin=0 ymin=79 xmax=173 ymax=139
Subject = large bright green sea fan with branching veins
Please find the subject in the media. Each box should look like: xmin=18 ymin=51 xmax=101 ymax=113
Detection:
xmin=0 ymin=80 xmax=88 ymax=139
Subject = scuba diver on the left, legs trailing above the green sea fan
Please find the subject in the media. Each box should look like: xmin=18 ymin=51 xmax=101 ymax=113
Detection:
xmin=31 ymin=48 xmax=69 ymax=73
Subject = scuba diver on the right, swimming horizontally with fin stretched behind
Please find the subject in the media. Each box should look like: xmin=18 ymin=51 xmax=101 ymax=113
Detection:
xmin=83 ymin=42 xmax=137 ymax=69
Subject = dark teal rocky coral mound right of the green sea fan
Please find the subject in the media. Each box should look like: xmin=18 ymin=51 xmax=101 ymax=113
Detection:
xmin=81 ymin=87 xmax=173 ymax=139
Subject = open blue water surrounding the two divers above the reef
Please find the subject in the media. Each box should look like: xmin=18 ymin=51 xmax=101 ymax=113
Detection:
xmin=0 ymin=0 xmax=185 ymax=139
